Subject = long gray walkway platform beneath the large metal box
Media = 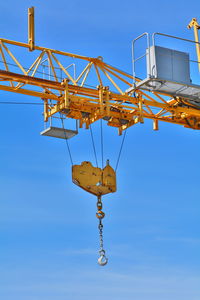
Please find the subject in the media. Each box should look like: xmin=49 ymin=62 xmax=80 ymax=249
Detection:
xmin=133 ymin=78 xmax=200 ymax=103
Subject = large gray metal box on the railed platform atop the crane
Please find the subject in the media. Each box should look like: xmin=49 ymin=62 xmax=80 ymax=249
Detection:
xmin=147 ymin=46 xmax=191 ymax=84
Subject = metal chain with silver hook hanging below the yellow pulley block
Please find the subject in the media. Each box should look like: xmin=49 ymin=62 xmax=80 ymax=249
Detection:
xmin=96 ymin=196 xmax=108 ymax=266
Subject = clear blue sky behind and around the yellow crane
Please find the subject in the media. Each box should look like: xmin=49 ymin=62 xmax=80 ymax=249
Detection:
xmin=0 ymin=0 xmax=200 ymax=300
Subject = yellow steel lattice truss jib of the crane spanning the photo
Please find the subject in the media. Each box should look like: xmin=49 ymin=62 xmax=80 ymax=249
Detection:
xmin=0 ymin=39 xmax=200 ymax=134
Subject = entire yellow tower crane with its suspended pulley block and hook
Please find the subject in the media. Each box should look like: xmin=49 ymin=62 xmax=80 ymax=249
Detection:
xmin=0 ymin=7 xmax=200 ymax=265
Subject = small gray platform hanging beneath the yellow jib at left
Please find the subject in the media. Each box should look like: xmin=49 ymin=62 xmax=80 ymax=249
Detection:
xmin=40 ymin=127 xmax=78 ymax=139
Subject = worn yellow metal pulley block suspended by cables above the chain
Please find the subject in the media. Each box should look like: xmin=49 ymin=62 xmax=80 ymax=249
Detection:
xmin=72 ymin=161 xmax=117 ymax=196
